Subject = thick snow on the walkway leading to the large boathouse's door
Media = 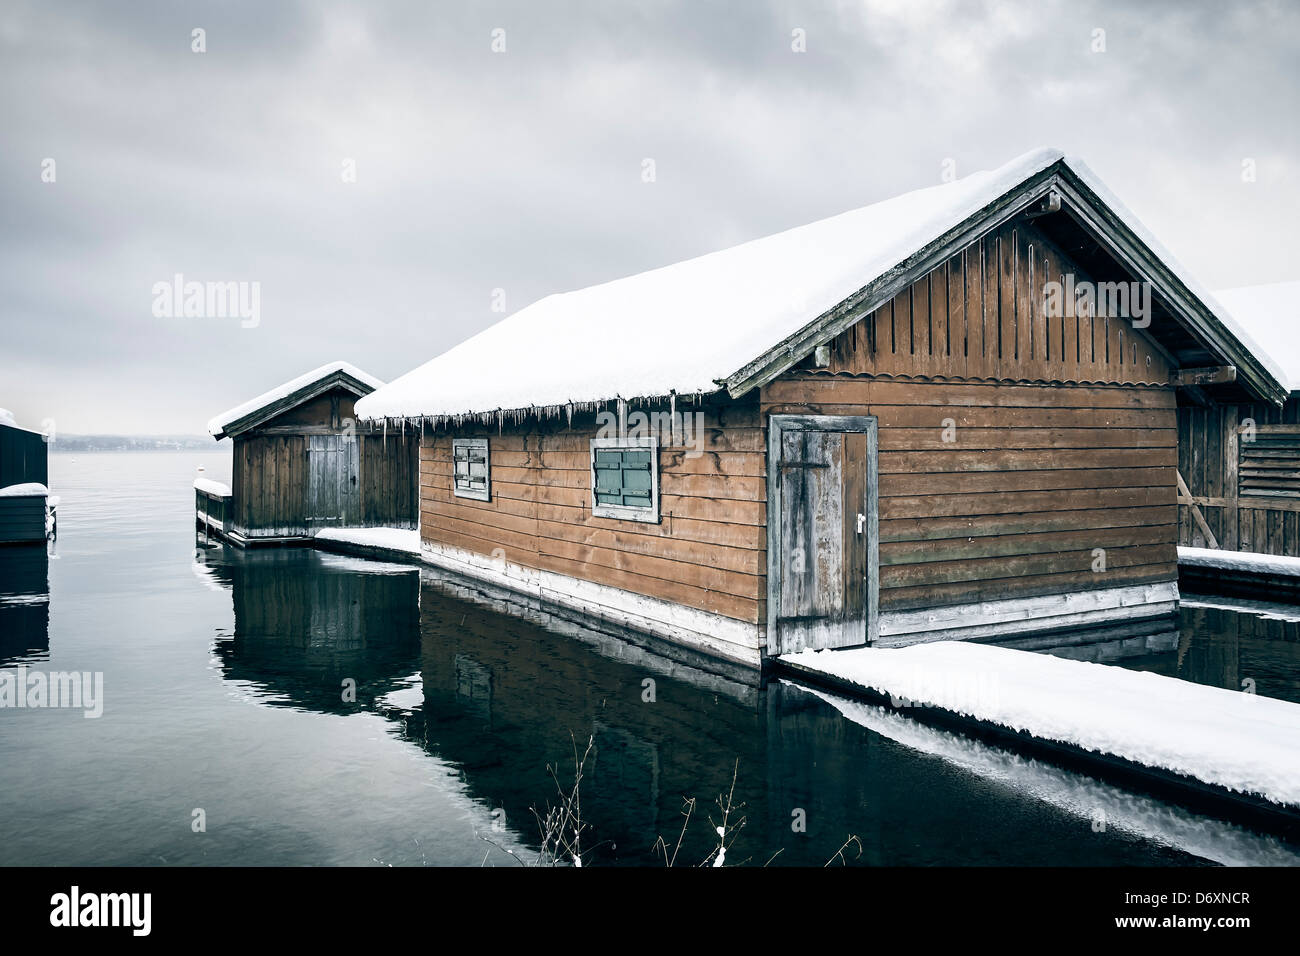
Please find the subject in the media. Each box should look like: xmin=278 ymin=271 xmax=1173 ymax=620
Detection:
xmin=781 ymin=641 xmax=1300 ymax=806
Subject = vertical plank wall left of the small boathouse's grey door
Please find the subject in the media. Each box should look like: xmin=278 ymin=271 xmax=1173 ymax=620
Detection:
xmin=230 ymin=434 xmax=307 ymax=537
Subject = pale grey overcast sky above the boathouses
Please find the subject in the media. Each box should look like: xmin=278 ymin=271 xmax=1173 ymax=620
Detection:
xmin=0 ymin=0 xmax=1300 ymax=433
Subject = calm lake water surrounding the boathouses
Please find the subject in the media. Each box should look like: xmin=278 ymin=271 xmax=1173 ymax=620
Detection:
xmin=0 ymin=453 xmax=1300 ymax=866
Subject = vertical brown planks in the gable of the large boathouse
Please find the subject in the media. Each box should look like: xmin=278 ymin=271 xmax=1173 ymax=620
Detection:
xmin=829 ymin=222 xmax=1170 ymax=385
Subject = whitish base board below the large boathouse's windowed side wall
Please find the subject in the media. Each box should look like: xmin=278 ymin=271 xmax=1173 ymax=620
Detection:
xmin=420 ymin=540 xmax=763 ymax=667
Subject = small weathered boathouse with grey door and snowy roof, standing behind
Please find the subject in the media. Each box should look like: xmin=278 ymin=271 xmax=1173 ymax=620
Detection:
xmin=195 ymin=362 xmax=419 ymax=546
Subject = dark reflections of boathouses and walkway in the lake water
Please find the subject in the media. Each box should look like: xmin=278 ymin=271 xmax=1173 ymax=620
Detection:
xmin=199 ymin=548 xmax=1297 ymax=865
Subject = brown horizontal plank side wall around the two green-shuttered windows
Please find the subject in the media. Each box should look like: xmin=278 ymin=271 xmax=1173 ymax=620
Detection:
xmin=420 ymin=401 xmax=767 ymax=624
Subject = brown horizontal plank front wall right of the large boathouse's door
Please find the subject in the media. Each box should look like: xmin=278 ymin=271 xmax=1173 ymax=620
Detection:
xmin=762 ymin=375 xmax=1178 ymax=610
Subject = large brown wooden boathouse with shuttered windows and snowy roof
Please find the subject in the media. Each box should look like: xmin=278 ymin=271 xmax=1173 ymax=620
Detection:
xmin=356 ymin=150 xmax=1286 ymax=666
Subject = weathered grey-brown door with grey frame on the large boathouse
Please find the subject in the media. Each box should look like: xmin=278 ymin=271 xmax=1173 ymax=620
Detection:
xmin=767 ymin=415 xmax=878 ymax=654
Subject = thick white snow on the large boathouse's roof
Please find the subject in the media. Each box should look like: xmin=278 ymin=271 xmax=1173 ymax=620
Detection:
xmin=356 ymin=148 xmax=1275 ymax=419
